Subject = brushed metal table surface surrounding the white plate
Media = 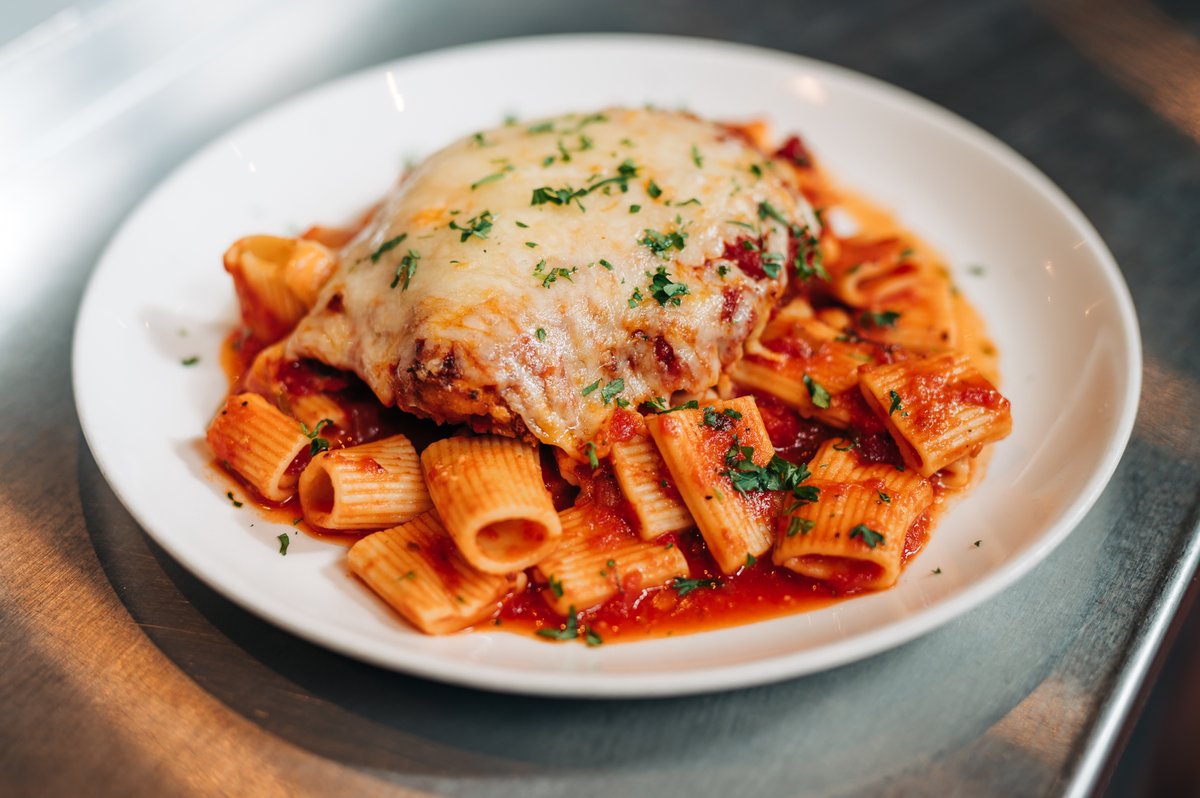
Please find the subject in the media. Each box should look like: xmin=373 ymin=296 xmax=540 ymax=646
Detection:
xmin=0 ymin=0 xmax=1200 ymax=798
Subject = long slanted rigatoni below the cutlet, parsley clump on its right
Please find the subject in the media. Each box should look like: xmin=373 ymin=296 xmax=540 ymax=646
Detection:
xmin=646 ymin=396 xmax=775 ymax=574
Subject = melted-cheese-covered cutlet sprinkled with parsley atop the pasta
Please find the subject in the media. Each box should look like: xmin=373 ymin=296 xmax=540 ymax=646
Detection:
xmin=287 ymin=109 xmax=812 ymax=456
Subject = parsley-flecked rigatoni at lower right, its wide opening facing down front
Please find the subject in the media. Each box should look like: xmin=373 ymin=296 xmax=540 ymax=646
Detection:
xmin=773 ymin=440 xmax=934 ymax=590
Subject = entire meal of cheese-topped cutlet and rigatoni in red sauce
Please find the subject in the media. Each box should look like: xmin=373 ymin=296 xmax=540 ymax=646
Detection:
xmin=208 ymin=108 xmax=1012 ymax=646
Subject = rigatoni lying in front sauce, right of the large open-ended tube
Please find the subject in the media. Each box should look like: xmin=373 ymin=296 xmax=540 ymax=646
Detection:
xmin=538 ymin=504 xmax=688 ymax=616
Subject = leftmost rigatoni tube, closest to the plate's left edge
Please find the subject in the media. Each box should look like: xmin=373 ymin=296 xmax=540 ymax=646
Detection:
xmin=208 ymin=394 xmax=311 ymax=502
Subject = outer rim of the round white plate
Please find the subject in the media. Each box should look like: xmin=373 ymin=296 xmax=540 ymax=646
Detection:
xmin=71 ymin=32 xmax=1142 ymax=698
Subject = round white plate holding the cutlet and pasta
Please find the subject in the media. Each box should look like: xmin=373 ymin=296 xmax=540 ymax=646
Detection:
xmin=74 ymin=36 xmax=1141 ymax=696
